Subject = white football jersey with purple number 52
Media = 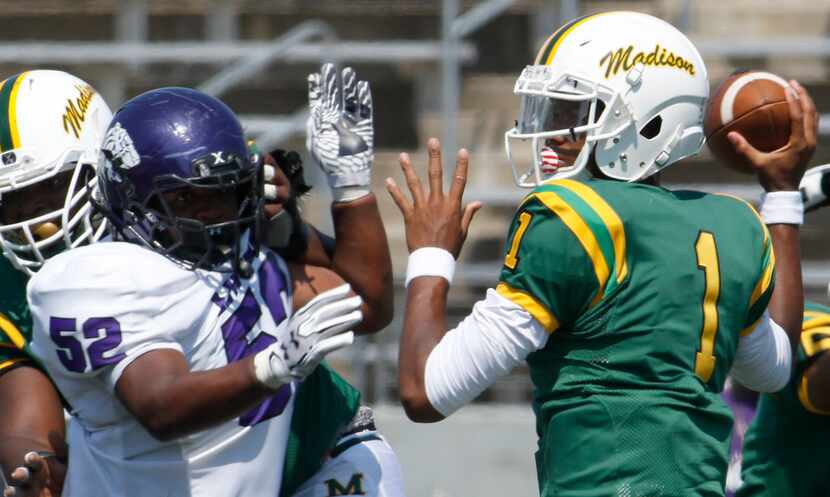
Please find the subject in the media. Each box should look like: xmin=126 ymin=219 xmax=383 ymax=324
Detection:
xmin=28 ymin=242 xmax=293 ymax=497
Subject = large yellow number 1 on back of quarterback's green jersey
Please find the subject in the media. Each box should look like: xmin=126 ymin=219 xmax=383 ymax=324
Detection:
xmin=695 ymin=231 xmax=720 ymax=381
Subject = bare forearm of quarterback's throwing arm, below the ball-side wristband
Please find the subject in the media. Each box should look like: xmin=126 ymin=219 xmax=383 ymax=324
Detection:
xmin=769 ymin=224 xmax=804 ymax=344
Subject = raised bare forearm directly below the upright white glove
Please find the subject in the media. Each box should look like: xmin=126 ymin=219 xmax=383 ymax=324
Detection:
xmin=332 ymin=194 xmax=394 ymax=333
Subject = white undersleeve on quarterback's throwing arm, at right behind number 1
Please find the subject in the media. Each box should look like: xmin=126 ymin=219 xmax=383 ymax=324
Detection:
xmin=731 ymin=312 xmax=792 ymax=393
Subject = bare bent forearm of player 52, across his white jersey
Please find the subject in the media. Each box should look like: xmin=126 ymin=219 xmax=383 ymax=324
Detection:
xmin=116 ymin=357 xmax=275 ymax=441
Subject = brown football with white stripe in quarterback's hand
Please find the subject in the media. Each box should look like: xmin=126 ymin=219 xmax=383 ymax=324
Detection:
xmin=703 ymin=71 xmax=790 ymax=174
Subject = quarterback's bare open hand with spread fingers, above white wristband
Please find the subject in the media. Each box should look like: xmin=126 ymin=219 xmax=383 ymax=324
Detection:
xmin=386 ymin=138 xmax=481 ymax=259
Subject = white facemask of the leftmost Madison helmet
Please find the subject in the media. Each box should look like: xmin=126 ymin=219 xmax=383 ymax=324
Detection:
xmin=0 ymin=149 xmax=106 ymax=276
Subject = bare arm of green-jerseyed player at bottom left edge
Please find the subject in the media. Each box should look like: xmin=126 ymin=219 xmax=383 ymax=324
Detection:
xmin=0 ymin=367 xmax=66 ymax=478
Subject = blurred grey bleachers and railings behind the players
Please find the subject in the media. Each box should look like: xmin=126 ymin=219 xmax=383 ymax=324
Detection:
xmin=0 ymin=0 xmax=830 ymax=497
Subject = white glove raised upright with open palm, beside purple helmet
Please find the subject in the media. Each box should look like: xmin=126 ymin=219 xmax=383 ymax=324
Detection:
xmin=306 ymin=64 xmax=375 ymax=202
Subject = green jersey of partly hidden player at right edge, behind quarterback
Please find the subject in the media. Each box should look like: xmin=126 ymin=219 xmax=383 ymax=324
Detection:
xmin=736 ymin=303 xmax=830 ymax=497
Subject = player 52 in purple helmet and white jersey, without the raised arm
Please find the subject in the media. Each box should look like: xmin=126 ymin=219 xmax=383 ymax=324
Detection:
xmin=28 ymin=88 xmax=363 ymax=497
